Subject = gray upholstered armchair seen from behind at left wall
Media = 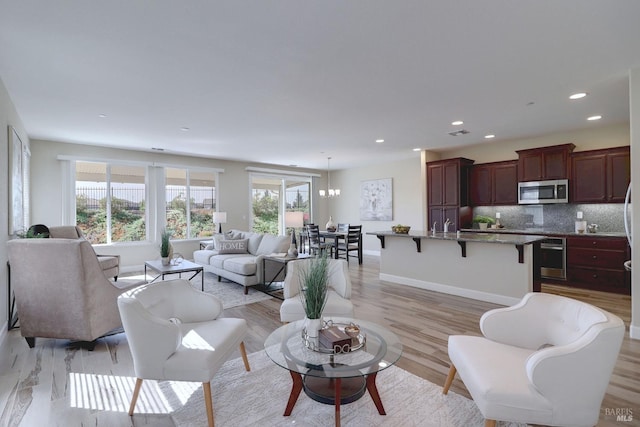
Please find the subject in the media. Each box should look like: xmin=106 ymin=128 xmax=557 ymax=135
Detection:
xmin=7 ymin=239 xmax=140 ymax=350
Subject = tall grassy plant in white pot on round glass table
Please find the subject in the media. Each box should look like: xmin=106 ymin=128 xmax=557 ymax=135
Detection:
xmin=300 ymin=255 xmax=329 ymax=338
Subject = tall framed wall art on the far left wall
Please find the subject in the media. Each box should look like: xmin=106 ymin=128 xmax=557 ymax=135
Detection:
xmin=9 ymin=126 xmax=24 ymax=235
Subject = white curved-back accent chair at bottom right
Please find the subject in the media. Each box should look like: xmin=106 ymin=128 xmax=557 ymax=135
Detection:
xmin=443 ymin=292 xmax=625 ymax=426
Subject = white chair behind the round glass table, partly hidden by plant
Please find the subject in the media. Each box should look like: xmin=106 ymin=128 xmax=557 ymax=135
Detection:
xmin=280 ymin=259 xmax=353 ymax=323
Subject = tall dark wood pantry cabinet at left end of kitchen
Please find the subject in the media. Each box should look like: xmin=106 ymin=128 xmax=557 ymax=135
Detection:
xmin=427 ymin=157 xmax=473 ymax=231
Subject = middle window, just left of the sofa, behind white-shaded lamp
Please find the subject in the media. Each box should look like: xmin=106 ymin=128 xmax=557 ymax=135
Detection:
xmin=165 ymin=168 xmax=216 ymax=239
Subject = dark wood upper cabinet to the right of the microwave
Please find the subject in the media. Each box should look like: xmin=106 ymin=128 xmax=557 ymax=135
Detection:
xmin=570 ymin=147 xmax=631 ymax=203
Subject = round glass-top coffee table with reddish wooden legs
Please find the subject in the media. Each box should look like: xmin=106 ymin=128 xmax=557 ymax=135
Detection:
xmin=264 ymin=318 xmax=402 ymax=426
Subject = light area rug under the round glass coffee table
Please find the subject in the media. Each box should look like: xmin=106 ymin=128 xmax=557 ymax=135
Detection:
xmin=156 ymin=351 xmax=525 ymax=427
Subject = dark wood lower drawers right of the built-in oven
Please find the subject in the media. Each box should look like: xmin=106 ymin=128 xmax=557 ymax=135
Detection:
xmin=567 ymin=235 xmax=631 ymax=295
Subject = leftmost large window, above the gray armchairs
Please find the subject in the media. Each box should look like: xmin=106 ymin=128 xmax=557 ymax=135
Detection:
xmin=75 ymin=161 xmax=147 ymax=244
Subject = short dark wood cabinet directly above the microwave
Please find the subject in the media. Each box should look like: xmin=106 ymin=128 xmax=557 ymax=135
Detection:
xmin=516 ymin=144 xmax=575 ymax=181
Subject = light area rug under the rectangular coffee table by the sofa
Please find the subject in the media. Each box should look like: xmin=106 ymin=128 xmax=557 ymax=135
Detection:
xmin=123 ymin=271 xmax=271 ymax=308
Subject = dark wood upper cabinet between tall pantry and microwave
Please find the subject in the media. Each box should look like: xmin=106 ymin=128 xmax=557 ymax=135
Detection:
xmin=469 ymin=160 xmax=518 ymax=206
